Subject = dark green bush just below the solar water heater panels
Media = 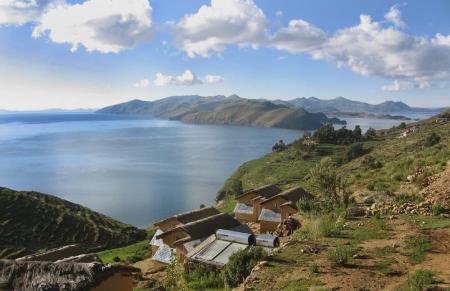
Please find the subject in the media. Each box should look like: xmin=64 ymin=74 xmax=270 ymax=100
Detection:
xmin=223 ymin=247 xmax=267 ymax=287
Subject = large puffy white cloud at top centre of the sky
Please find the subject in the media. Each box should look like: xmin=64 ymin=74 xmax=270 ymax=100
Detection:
xmin=175 ymin=0 xmax=267 ymax=58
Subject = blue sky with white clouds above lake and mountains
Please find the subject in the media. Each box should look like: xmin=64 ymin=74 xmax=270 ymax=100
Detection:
xmin=0 ymin=0 xmax=450 ymax=110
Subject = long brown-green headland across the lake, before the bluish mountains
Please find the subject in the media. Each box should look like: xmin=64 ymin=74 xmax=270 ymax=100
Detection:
xmin=97 ymin=95 xmax=345 ymax=130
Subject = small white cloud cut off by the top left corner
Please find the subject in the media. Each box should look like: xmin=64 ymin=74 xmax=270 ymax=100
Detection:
xmin=0 ymin=0 xmax=43 ymax=25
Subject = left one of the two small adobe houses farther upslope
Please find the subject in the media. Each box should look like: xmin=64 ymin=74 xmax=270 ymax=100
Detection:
xmin=234 ymin=185 xmax=282 ymax=222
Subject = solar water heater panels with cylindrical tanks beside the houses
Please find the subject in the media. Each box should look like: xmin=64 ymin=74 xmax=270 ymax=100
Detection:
xmin=186 ymin=229 xmax=280 ymax=268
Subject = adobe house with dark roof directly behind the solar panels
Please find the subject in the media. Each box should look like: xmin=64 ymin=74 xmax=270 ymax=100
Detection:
xmin=156 ymin=213 xmax=251 ymax=259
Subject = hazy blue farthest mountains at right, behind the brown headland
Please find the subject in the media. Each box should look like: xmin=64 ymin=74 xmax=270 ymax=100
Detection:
xmin=273 ymin=97 xmax=447 ymax=114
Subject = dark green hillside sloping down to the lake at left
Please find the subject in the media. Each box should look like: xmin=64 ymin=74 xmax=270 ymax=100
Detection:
xmin=0 ymin=188 xmax=146 ymax=258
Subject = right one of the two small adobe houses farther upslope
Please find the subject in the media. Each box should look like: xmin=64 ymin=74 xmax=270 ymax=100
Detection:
xmin=258 ymin=187 xmax=313 ymax=233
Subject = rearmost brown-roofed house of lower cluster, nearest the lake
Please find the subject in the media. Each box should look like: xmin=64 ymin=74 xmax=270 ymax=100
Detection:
xmin=154 ymin=207 xmax=220 ymax=232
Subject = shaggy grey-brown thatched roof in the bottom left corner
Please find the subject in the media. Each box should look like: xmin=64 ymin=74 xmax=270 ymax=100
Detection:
xmin=0 ymin=260 xmax=140 ymax=291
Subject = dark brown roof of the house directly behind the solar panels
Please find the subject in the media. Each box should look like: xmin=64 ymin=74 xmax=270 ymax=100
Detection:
xmin=157 ymin=213 xmax=241 ymax=239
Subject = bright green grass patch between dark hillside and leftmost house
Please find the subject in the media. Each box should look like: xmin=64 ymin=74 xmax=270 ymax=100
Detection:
xmin=97 ymin=240 xmax=152 ymax=264
